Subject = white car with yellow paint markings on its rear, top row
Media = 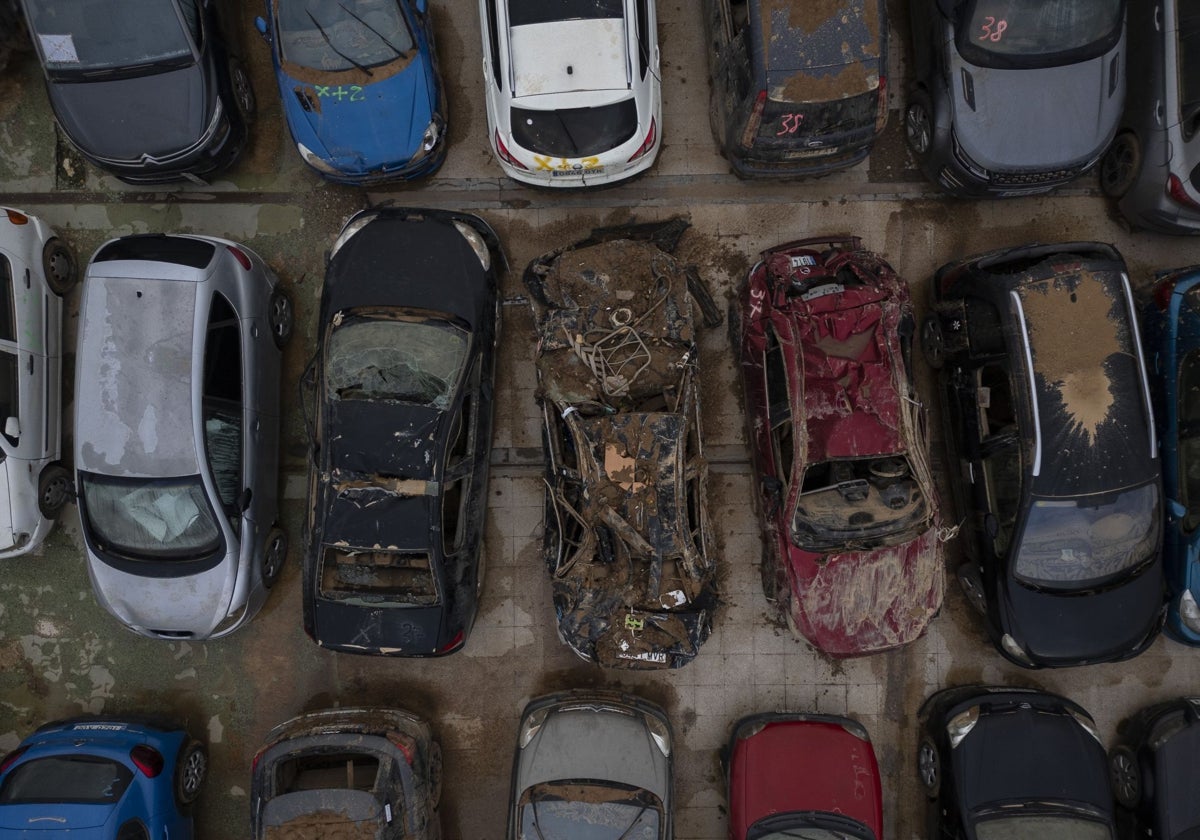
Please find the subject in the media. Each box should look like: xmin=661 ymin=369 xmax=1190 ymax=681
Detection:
xmin=480 ymin=0 xmax=662 ymax=187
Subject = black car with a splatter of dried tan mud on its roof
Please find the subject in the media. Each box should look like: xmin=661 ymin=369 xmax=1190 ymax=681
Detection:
xmin=920 ymin=242 xmax=1165 ymax=667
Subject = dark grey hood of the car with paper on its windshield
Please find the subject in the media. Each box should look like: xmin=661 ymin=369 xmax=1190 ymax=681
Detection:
xmin=47 ymin=65 xmax=212 ymax=161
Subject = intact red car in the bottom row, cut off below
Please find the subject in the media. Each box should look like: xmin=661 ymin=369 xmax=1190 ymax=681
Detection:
xmin=728 ymin=714 xmax=883 ymax=840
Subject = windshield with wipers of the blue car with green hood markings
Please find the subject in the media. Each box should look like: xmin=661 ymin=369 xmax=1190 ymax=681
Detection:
xmin=275 ymin=0 xmax=415 ymax=73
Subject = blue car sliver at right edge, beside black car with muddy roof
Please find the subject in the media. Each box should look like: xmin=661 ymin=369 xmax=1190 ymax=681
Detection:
xmin=1142 ymin=265 xmax=1200 ymax=644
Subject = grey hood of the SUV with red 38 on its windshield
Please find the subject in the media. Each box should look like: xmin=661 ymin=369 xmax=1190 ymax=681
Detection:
xmin=950 ymin=47 xmax=1124 ymax=169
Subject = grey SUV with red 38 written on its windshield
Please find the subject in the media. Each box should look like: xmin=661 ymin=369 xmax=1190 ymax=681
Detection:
xmin=905 ymin=0 xmax=1123 ymax=197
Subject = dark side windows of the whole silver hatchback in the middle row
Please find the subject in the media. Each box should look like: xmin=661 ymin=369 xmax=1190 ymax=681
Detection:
xmin=203 ymin=294 xmax=242 ymax=522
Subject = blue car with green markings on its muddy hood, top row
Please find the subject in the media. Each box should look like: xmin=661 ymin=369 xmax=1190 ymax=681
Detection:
xmin=254 ymin=0 xmax=446 ymax=185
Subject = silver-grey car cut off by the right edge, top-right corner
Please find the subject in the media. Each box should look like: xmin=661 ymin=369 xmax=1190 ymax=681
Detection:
xmin=1100 ymin=0 xmax=1200 ymax=233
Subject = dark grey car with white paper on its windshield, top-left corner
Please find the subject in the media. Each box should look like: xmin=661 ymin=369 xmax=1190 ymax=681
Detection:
xmin=23 ymin=0 xmax=254 ymax=184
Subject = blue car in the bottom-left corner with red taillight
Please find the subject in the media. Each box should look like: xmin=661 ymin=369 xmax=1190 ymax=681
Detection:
xmin=0 ymin=718 xmax=208 ymax=840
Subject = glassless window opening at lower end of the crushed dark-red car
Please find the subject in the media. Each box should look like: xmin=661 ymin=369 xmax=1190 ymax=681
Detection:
xmin=792 ymin=455 xmax=928 ymax=551
